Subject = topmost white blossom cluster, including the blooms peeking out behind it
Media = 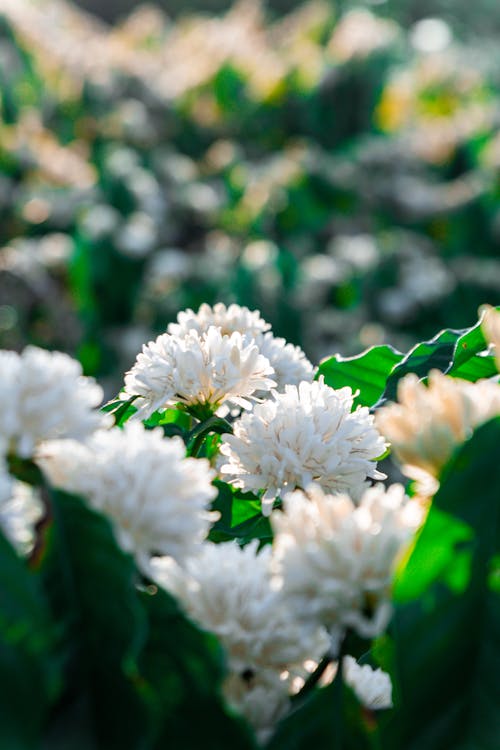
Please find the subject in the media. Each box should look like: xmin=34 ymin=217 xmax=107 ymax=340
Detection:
xmin=122 ymin=303 xmax=313 ymax=419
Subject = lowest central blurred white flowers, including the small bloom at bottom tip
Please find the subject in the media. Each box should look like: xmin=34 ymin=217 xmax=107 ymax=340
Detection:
xmin=152 ymin=541 xmax=329 ymax=739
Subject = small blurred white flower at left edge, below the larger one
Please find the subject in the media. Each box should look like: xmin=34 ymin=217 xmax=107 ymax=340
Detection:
xmin=0 ymin=476 xmax=43 ymax=555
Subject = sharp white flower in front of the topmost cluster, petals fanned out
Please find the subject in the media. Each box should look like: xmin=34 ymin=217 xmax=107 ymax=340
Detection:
xmin=125 ymin=326 xmax=275 ymax=419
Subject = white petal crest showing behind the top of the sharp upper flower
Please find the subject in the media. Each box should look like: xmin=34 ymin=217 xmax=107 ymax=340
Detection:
xmin=167 ymin=302 xmax=271 ymax=338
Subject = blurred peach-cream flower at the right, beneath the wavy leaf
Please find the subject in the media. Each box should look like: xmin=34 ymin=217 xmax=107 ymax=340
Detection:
xmin=376 ymin=370 xmax=500 ymax=492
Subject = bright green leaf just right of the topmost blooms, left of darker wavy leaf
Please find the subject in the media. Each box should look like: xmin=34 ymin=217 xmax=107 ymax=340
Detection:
xmin=316 ymin=345 xmax=403 ymax=406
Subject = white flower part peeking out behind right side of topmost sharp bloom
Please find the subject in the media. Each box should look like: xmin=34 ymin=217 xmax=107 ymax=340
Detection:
xmin=255 ymin=332 xmax=314 ymax=392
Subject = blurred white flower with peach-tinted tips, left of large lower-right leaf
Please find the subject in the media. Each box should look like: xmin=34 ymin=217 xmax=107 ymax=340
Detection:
xmin=271 ymin=484 xmax=421 ymax=637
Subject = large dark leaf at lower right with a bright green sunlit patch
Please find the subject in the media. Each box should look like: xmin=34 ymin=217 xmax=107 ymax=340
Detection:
xmin=384 ymin=418 xmax=500 ymax=750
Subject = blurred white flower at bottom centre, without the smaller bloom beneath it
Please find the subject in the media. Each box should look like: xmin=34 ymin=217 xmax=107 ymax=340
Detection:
xmin=151 ymin=540 xmax=329 ymax=679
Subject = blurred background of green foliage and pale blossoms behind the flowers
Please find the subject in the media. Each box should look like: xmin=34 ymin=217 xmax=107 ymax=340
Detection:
xmin=0 ymin=0 xmax=500 ymax=391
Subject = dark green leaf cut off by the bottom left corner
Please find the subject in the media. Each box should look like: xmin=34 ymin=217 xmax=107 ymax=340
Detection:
xmin=0 ymin=533 xmax=60 ymax=750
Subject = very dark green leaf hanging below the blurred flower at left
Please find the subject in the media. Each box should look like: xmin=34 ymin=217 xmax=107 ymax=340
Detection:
xmin=39 ymin=492 xmax=148 ymax=750
